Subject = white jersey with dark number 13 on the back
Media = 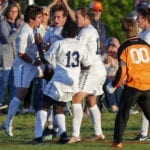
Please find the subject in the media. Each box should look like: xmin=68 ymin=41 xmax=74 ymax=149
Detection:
xmin=44 ymin=38 xmax=92 ymax=101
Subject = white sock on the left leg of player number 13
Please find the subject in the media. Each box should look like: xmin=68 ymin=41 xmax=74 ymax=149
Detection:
xmin=34 ymin=110 xmax=47 ymax=138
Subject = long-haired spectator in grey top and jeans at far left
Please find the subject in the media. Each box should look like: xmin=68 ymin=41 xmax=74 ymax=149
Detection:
xmin=0 ymin=3 xmax=23 ymax=109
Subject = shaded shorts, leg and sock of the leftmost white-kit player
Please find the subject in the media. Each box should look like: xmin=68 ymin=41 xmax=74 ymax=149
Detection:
xmin=2 ymin=66 xmax=35 ymax=136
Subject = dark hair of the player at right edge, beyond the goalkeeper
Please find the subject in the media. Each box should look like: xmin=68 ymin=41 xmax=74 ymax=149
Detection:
xmin=137 ymin=7 xmax=150 ymax=23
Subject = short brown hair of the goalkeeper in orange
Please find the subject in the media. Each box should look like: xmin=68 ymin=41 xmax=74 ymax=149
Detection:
xmin=120 ymin=18 xmax=138 ymax=38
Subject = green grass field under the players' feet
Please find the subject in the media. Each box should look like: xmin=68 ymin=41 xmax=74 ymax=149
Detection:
xmin=0 ymin=110 xmax=150 ymax=150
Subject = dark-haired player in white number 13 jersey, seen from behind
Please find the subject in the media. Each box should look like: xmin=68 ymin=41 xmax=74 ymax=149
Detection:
xmin=34 ymin=21 xmax=92 ymax=144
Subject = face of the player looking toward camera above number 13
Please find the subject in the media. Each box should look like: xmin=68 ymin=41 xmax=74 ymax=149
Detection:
xmin=53 ymin=11 xmax=67 ymax=27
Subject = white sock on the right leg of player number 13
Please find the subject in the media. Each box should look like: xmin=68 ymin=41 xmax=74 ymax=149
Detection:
xmin=54 ymin=114 xmax=66 ymax=135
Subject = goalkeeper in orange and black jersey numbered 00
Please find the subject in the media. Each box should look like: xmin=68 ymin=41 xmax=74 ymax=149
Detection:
xmin=107 ymin=18 xmax=150 ymax=148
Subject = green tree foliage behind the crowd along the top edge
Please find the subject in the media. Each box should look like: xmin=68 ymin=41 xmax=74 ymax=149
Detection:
xmin=31 ymin=0 xmax=134 ymax=41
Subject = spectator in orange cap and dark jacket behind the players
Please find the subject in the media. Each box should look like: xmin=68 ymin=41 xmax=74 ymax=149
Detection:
xmin=89 ymin=0 xmax=106 ymax=53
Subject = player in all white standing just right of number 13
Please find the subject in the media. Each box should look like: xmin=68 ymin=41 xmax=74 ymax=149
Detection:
xmin=68 ymin=8 xmax=106 ymax=143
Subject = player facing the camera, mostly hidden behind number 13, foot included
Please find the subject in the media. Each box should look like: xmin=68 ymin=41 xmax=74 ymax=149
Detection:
xmin=36 ymin=3 xmax=68 ymax=139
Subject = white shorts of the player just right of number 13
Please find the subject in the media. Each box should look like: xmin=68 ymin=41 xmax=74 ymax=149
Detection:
xmin=79 ymin=63 xmax=106 ymax=96
